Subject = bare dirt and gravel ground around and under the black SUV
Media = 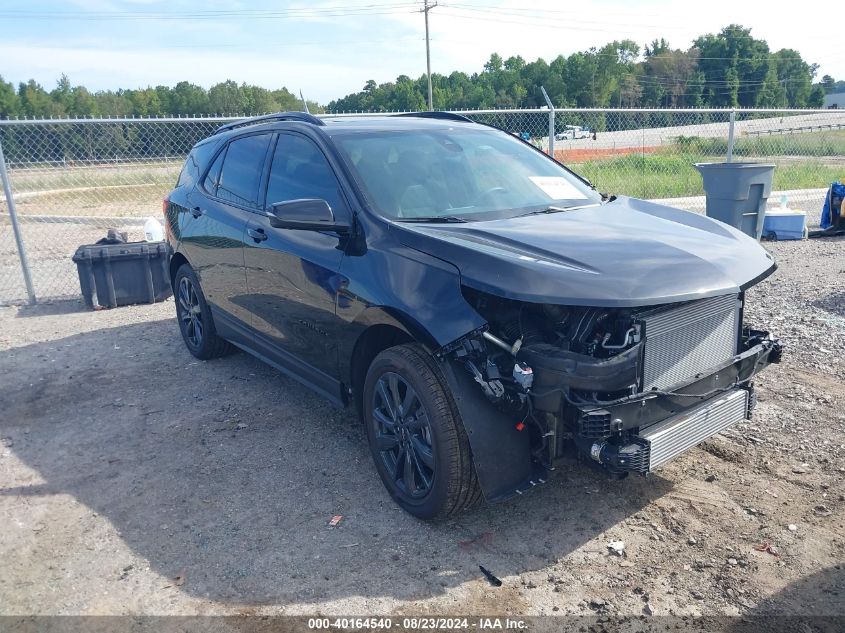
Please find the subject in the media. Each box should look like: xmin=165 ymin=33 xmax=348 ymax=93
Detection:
xmin=0 ymin=239 xmax=845 ymax=617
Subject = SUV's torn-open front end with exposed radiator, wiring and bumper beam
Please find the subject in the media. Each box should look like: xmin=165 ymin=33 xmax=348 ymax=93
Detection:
xmin=439 ymin=287 xmax=781 ymax=498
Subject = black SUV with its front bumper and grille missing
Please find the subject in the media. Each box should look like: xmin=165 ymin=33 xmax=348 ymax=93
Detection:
xmin=164 ymin=112 xmax=780 ymax=518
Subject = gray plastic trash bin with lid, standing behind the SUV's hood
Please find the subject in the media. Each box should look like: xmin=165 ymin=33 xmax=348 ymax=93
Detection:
xmin=695 ymin=163 xmax=775 ymax=240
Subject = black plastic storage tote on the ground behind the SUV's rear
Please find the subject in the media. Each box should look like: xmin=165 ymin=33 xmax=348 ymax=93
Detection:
xmin=73 ymin=242 xmax=173 ymax=309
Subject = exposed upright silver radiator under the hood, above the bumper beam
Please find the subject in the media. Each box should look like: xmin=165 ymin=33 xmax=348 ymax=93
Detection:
xmin=642 ymin=295 xmax=740 ymax=391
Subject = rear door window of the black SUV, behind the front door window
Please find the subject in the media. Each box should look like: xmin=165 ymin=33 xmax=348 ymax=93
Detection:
xmin=217 ymin=134 xmax=271 ymax=206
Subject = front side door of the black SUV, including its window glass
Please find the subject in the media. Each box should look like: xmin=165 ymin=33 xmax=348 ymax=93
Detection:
xmin=244 ymin=132 xmax=351 ymax=398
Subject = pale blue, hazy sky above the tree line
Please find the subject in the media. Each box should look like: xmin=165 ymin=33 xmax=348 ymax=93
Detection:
xmin=0 ymin=0 xmax=845 ymax=103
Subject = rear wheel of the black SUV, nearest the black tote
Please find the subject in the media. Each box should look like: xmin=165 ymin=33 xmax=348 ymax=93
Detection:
xmin=173 ymin=264 xmax=232 ymax=360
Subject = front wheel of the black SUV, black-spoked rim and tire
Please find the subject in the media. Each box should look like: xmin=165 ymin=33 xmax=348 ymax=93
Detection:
xmin=364 ymin=344 xmax=481 ymax=520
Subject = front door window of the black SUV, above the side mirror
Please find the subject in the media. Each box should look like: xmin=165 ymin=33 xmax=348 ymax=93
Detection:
xmin=266 ymin=134 xmax=348 ymax=217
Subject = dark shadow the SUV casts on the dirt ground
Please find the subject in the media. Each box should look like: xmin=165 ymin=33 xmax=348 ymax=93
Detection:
xmin=0 ymin=319 xmax=671 ymax=605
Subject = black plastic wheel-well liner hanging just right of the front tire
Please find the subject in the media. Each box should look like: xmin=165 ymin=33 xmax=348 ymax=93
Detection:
xmin=440 ymin=360 xmax=547 ymax=503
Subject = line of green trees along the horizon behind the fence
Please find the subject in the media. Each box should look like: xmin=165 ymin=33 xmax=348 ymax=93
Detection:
xmin=0 ymin=25 xmax=845 ymax=118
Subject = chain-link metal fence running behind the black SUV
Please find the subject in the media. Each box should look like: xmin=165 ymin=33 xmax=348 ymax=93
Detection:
xmin=0 ymin=109 xmax=845 ymax=303
